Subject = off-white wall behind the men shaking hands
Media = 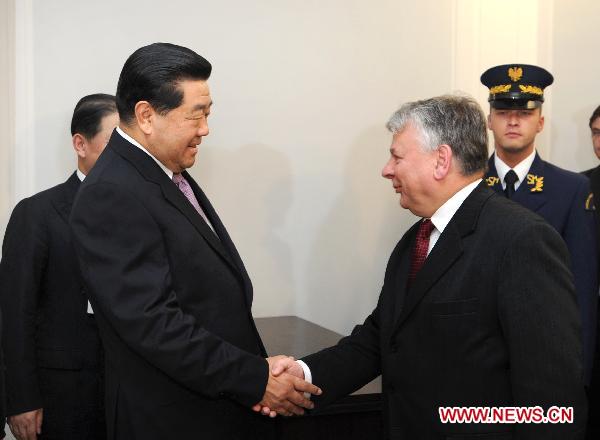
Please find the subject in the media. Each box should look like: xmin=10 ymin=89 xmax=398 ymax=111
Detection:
xmin=5 ymin=0 xmax=600 ymax=340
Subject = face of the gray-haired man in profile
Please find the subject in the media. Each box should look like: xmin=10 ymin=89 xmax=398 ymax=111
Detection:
xmin=381 ymin=125 xmax=436 ymax=217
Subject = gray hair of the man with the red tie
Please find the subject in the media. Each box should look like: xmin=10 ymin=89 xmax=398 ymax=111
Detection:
xmin=386 ymin=95 xmax=488 ymax=176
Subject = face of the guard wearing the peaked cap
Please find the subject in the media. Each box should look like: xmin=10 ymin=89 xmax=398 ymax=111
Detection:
xmin=488 ymin=108 xmax=544 ymax=153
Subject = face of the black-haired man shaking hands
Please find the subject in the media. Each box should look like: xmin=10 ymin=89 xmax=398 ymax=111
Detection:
xmin=152 ymin=80 xmax=212 ymax=173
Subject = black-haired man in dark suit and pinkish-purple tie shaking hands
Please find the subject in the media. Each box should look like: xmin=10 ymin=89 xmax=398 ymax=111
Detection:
xmin=71 ymin=43 xmax=318 ymax=440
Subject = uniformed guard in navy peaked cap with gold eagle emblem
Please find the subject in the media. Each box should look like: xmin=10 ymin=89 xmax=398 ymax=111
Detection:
xmin=481 ymin=64 xmax=598 ymax=385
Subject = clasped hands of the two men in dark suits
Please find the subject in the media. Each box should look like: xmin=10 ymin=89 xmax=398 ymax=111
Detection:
xmin=252 ymin=355 xmax=322 ymax=417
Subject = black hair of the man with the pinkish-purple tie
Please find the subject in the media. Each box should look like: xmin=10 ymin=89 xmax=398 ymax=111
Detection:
xmin=117 ymin=43 xmax=212 ymax=124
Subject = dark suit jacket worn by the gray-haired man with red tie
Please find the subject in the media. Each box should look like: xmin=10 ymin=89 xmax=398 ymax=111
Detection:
xmin=304 ymin=183 xmax=586 ymax=440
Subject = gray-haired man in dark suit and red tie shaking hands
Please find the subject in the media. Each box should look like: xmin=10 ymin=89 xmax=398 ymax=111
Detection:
xmin=264 ymin=96 xmax=586 ymax=440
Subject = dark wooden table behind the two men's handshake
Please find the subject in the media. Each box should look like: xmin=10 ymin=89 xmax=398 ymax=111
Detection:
xmin=255 ymin=316 xmax=382 ymax=440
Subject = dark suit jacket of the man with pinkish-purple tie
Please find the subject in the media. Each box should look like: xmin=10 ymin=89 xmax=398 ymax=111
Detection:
xmin=71 ymin=131 xmax=268 ymax=440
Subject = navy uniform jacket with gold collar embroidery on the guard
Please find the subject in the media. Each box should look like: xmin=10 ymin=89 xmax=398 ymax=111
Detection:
xmin=486 ymin=154 xmax=598 ymax=384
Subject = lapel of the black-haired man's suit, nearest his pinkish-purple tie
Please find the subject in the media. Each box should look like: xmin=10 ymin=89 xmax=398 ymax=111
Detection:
xmin=107 ymin=130 xmax=239 ymax=272
